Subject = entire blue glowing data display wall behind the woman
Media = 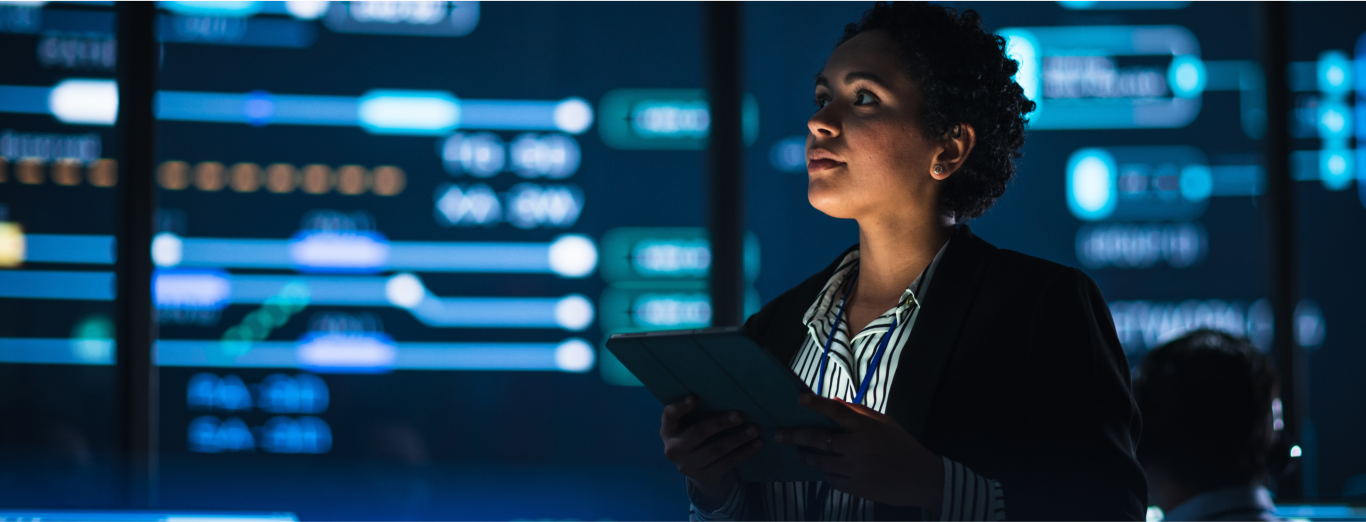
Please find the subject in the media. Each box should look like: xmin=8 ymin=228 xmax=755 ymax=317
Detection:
xmin=0 ymin=0 xmax=1366 ymax=522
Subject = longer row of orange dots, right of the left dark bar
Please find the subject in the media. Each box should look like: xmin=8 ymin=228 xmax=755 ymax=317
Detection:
xmin=157 ymin=161 xmax=407 ymax=195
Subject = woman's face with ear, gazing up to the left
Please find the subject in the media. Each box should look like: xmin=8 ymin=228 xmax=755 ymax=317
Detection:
xmin=806 ymin=30 xmax=947 ymax=220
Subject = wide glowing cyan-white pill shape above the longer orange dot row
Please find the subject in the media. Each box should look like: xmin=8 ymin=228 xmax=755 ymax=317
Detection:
xmin=357 ymin=90 xmax=460 ymax=135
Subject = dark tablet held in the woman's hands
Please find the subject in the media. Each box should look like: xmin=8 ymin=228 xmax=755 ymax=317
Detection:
xmin=607 ymin=328 xmax=840 ymax=482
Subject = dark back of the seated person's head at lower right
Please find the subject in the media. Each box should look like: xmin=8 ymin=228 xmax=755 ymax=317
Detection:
xmin=1134 ymin=329 xmax=1283 ymax=521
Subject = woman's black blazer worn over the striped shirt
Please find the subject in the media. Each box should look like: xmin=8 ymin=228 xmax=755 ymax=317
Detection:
xmin=746 ymin=225 xmax=1147 ymax=522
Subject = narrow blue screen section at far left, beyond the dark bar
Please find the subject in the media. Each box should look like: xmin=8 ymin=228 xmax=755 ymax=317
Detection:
xmin=0 ymin=1 xmax=123 ymax=507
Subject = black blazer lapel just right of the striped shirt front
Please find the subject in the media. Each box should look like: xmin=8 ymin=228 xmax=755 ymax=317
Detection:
xmin=887 ymin=225 xmax=996 ymax=439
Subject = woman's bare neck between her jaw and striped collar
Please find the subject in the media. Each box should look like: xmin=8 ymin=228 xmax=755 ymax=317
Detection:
xmin=854 ymin=214 xmax=953 ymax=307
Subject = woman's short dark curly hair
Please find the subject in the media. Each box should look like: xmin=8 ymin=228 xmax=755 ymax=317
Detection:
xmin=840 ymin=0 xmax=1034 ymax=221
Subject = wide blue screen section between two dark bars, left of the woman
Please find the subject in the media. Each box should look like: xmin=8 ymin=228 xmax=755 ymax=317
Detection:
xmin=153 ymin=0 xmax=708 ymax=521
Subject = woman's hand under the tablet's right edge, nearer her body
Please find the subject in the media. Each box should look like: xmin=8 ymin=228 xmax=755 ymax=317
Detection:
xmin=776 ymin=394 xmax=944 ymax=511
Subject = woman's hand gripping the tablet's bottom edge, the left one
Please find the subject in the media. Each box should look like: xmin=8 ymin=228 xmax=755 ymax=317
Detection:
xmin=660 ymin=395 xmax=764 ymax=511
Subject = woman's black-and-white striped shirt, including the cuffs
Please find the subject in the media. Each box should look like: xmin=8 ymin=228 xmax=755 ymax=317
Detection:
xmin=688 ymin=243 xmax=1005 ymax=522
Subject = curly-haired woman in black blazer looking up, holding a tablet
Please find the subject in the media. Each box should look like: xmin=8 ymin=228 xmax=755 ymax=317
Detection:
xmin=660 ymin=0 xmax=1147 ymax=522
